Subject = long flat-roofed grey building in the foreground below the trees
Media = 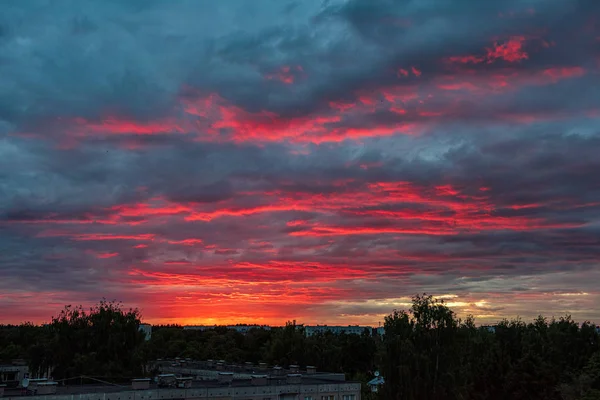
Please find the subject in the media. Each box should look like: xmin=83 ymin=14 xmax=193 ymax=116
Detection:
xmin=3 ymin=359 xmax=361 ymax=400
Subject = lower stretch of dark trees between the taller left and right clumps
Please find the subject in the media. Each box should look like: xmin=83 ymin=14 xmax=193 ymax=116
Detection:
xmin=148 ymin=323 xmax=377 ymax=375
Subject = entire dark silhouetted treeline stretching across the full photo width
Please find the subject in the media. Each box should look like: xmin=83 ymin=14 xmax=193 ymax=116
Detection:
xmin=0 ymin=295 xmax=600 ymax=400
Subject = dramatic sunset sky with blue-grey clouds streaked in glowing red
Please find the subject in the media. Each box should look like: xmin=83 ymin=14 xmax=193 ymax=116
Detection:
xmin=0 ymin=0 xmax=600 ymax=325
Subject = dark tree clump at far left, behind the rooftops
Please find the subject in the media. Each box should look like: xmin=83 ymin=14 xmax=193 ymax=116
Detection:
xmin=0 ymin=300 xmax=145 ymax=379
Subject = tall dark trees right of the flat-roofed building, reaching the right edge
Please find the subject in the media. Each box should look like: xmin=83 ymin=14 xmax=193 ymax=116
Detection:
xmin=382 ymin=295 xmax=600 ymax=399
